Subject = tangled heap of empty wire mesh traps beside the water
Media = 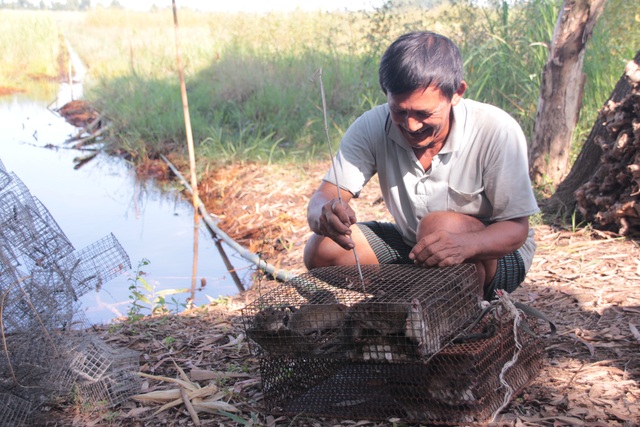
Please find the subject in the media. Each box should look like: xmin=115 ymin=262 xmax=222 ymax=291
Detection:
xmin=0 ymin=162 xmax=139 ymax=426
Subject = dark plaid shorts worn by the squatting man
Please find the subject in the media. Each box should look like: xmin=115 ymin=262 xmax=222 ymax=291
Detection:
xmin=358 ymin=221 xmax=527 ymax=300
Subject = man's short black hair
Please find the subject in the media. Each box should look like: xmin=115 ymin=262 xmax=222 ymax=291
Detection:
xmin=378 ymin=31 xmax=463 ymax=99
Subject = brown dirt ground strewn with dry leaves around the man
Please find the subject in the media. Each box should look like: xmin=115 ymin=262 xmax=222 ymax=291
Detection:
xmin=38 ymin=157 xmax=640 ymax=427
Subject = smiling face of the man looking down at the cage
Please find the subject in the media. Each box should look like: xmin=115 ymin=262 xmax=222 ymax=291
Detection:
xmin=387 ymin=86 xmax=466 ymax=149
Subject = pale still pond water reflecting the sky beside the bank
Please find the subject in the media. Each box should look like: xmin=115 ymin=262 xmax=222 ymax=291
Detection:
xmin=0 ymin=83 xmax=252 ymax=323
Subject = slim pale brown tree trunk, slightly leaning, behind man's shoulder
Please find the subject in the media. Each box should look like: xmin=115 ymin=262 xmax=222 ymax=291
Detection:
xmin=529 ymin=0 xmax=606 ymax=187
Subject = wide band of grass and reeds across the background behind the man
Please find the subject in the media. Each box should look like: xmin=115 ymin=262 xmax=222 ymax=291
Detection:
xmin=1 ymin=0 xmax=640 ymax=170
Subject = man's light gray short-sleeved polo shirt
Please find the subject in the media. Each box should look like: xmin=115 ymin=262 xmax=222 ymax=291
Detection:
xmin=323 ymin=99 xmax=539 ymax=270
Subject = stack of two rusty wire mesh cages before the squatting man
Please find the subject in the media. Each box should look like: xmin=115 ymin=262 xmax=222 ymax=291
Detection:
xmin=243 ymin=264 xmax=543 ymax=425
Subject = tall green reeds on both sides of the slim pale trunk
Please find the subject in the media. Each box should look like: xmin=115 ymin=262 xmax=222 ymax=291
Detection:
xmin=443 ymin=0 xmax=640 ymax=163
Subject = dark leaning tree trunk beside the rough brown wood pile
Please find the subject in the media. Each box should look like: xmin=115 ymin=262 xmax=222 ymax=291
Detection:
xmin=542 ymin=51 xmax=640 ymax=219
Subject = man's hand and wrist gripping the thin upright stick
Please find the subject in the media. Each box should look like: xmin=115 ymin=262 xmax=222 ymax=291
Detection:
xmin=307 ymin=181 xmax=356 ymax=250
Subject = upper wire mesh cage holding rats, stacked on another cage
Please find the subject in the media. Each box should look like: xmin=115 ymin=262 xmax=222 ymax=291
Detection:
xmin=243 ymin=264 xmax=480 ymax=360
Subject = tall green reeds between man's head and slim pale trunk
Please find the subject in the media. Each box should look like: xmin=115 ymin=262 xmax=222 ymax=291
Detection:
xmin=444 ymin=0 xmax=558 ymax=140
